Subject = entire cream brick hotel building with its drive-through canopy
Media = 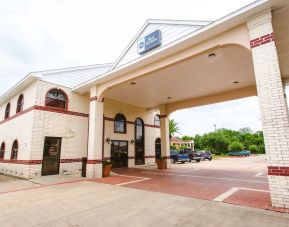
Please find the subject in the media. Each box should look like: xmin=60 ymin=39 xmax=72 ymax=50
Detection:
xmin=0 ymin=0 xmax=289 ymax=208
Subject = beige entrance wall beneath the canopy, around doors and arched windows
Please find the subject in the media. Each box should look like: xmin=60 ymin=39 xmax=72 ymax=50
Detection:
xmin=104 ymin=99 xmax=160 ymax=167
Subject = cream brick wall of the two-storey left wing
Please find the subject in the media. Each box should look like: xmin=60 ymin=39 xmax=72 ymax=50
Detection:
xmin=0 ymin=80 xmax=89 ymax=178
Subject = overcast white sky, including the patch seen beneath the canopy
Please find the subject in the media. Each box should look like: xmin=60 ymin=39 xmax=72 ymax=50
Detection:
xmin=0 ymin=0 xmax=261 ymax=135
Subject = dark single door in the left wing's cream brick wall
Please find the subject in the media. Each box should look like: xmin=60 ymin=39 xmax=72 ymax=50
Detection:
xmin=41 ymin=137 xmax=61 ymax=176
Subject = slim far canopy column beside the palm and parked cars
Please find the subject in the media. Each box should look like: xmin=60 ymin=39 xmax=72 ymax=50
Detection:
xmin=160 ymin=104 xmax=171 ymax=168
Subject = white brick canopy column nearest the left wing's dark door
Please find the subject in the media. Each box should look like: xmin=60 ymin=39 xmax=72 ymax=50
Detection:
xmin=86 ymin=88 xmax=103 ymax=178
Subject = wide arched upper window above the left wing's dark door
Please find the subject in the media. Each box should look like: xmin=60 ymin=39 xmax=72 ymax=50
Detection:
xmin=45 ymin=89 xmax=68 ymax=110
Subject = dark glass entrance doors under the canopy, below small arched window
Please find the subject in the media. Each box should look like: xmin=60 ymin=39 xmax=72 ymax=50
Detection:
xmin=111 ymin=140 xmax=128 ymax=168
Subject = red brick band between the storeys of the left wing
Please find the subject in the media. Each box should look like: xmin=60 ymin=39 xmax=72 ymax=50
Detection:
xmin=0 ymin=105 xmax=89 ymax=125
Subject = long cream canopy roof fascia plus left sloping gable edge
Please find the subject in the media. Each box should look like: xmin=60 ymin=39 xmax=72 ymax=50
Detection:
xmin=73 ymin=0 xmax=280 ymax=93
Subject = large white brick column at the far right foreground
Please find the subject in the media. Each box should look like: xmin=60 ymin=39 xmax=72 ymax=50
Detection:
xmin=247 ymin=10 xmax=289 ymax=208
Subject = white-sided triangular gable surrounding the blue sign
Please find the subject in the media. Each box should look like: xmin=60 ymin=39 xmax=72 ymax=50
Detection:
xmin=111 ymin=20 xmax=210 ymax=69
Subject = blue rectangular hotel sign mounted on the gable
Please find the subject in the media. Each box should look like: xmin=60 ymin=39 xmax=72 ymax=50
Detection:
xmin=137 ymin=30 xmax=162 ymax=54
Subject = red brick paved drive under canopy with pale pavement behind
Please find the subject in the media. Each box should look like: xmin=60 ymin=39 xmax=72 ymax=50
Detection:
xmin=96 ymin=155 xmax=287 ymax=212
